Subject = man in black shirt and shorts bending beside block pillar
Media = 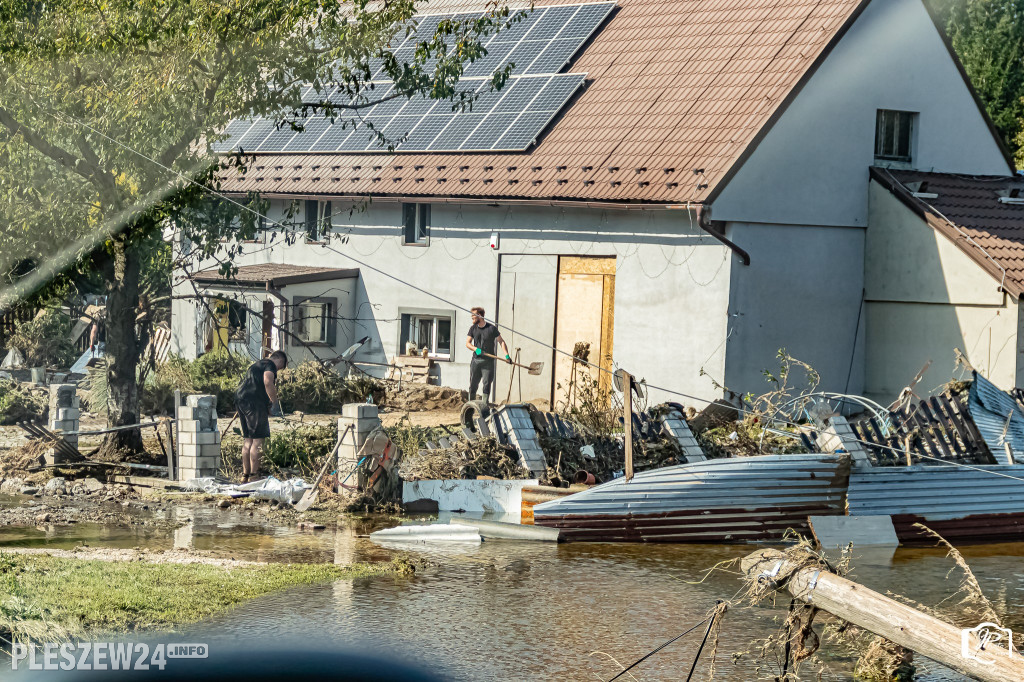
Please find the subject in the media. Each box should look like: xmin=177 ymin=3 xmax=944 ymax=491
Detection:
xmin=234 ymin=350 xmax=288 ymax=483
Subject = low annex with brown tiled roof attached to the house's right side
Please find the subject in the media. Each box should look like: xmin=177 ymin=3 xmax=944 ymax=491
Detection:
xmin=864 ymin=168 xmax=1024 ymax=399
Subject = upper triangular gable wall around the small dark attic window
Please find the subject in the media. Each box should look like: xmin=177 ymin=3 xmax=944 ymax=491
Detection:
xmin=713 ymin=0 xmax=1013 ymax=226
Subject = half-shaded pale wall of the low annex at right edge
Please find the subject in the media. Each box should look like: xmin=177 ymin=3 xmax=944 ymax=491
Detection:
xmin=864 ymin=182 xmax=1022 ymax=401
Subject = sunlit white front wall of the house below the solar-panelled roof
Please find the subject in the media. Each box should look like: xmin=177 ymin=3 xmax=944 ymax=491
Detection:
xmin=173 ymin=200 xmax=730 ymax=404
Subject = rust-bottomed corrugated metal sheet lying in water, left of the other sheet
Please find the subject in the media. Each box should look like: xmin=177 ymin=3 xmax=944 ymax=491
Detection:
xmin=534 ymin=454 xmax=850 ymax=542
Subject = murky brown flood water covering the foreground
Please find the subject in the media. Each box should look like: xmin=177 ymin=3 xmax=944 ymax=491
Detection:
xmin=0 ymin=491 xmax=1024 ymax=682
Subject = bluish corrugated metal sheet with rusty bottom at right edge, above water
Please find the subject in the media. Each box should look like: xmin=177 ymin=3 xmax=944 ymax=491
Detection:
xmin=848 ymin=465 xmax=1024 ymax=544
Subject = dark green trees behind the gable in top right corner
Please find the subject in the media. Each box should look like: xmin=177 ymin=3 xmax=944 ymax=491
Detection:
xmin=932 ymin=0 xmax=1024 ymax=168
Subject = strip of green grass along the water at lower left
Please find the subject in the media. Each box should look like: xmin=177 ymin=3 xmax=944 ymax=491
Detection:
xmin=0 ymin=553 xmax=411 ymax=641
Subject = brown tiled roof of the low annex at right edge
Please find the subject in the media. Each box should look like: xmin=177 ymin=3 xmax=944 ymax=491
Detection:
xmin=871 ymin=168 xmax=1024 ymax=298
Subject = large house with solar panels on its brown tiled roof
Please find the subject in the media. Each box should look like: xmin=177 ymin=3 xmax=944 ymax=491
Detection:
xmin=174 ymin=0 xmax=1012 ymax=401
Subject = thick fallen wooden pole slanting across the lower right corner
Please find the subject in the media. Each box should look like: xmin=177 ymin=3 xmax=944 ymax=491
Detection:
xmin=740 ymin=549 xmax=1024 ymax=682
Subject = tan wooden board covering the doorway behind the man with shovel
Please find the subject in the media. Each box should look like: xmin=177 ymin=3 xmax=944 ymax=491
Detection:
xmin=552 ymin=256 xmax=615 ymax=403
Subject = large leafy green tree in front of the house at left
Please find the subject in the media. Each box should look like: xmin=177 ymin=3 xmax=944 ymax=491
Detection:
xmin=0 ymin=0 xmax=512 ymax=451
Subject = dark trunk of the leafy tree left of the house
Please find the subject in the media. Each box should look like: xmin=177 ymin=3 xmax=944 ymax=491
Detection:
xmin=100 ymin=239 xmax=145 ymax=459
